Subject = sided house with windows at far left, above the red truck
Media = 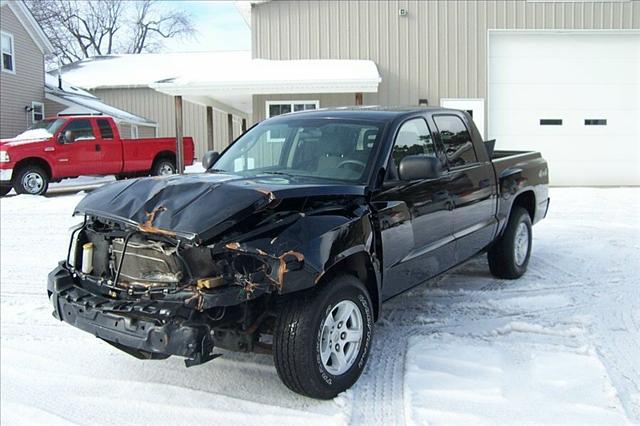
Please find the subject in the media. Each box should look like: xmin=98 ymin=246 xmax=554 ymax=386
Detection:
xmin=0 ymin=1 xmax=53 ymax=138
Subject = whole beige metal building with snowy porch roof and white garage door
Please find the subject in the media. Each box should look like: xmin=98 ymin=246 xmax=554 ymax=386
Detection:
xmin=52 ymin=0 xmax=640 ymax=185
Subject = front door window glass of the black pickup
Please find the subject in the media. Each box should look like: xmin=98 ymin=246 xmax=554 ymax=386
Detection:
xmin=387 ymin=118 xmax=437 ymax=180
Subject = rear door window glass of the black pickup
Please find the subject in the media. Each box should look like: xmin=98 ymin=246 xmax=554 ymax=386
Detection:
xmin=433 ymin=115 xmax=478 ymax=167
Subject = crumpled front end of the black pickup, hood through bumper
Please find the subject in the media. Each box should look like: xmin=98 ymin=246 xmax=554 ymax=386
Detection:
xmin=48 ymin=174 xmax=380 ymax=366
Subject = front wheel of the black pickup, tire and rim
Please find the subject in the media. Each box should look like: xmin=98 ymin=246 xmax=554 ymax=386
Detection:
xmin=273 ymin=275 xmax=373 ymax=399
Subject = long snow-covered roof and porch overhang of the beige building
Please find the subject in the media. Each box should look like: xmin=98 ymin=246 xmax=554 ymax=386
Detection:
xmin=56 ymin=51 xmax=381 ymax=114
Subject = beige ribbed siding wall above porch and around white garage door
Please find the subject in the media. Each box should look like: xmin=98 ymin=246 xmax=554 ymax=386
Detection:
xmin=251 ymin=0 xmax=640 ymax=121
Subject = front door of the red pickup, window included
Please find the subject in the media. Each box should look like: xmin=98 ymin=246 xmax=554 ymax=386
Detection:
xmin=53 ymin=118 xmax=100 ymax=177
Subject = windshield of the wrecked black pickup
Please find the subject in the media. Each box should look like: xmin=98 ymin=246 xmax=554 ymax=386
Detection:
xmin=213 ymin=117 xmax=383 ymax=183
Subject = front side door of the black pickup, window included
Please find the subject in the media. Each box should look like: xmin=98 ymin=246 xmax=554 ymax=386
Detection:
xmin=373 ymin=117 xmax=454 ymax=299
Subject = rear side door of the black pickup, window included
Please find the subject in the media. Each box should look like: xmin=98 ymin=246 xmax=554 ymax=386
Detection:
xmin=432 ymin=114 xmax=497 ymax=263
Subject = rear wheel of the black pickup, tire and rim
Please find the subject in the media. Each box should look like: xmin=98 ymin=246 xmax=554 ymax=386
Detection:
xmin=487 ymin=207 xmax=533 ymax=279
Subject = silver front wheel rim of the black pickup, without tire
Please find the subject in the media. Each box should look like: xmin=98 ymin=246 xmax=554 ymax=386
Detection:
xmin=320 ymin=300 xmax=364 ymax=376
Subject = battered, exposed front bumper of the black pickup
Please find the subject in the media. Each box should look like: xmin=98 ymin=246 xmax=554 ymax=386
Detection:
xmin=47 ymin=265 xmax=213 ymax=366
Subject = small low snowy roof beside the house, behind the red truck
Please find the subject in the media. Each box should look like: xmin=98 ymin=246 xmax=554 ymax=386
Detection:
xmin=45 ymin=74 xmax=156 ymax=126
